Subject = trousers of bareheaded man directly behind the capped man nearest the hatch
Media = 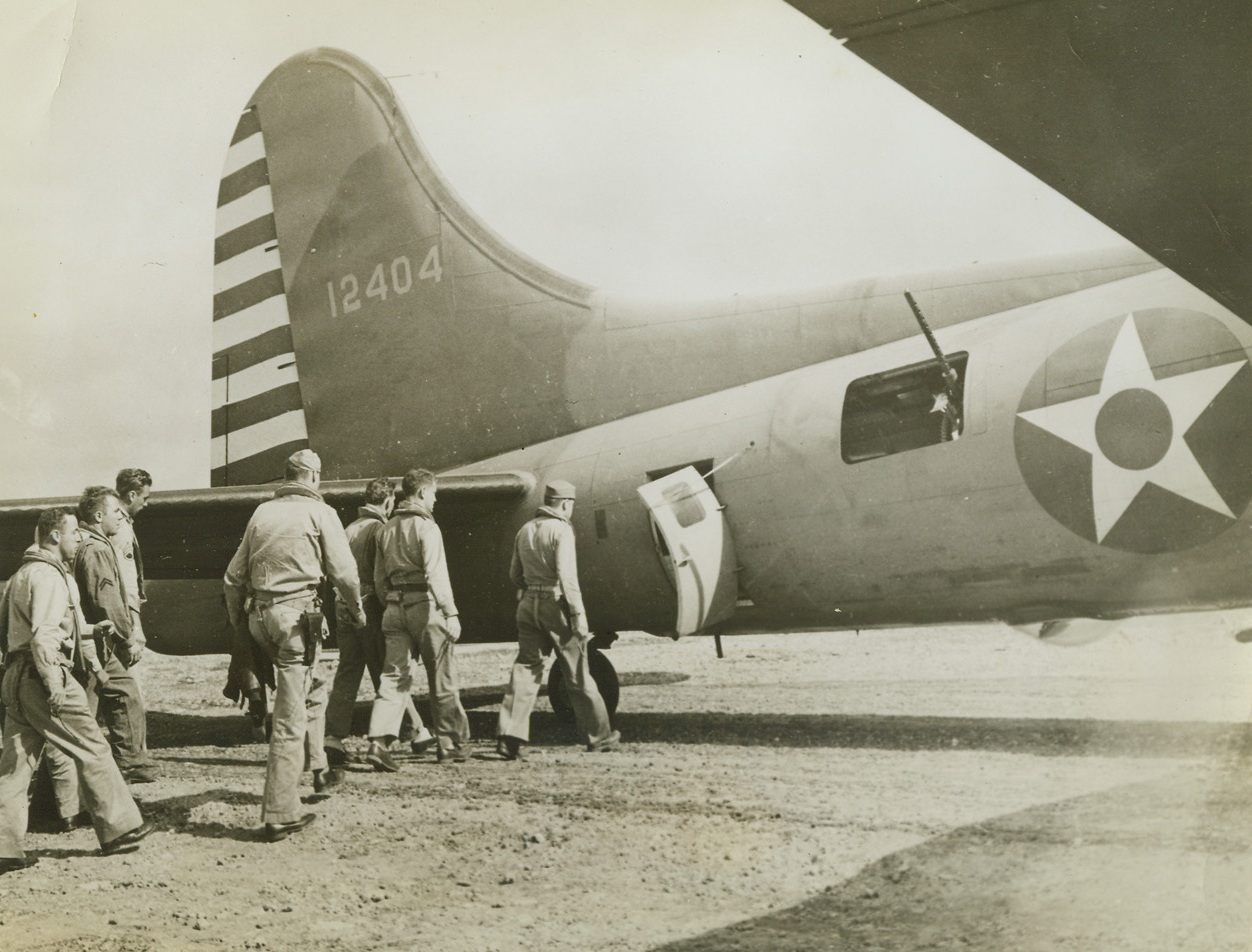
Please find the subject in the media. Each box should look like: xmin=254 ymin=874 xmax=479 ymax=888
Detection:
xmin=369 ymin=592 xmax=470 ymax=750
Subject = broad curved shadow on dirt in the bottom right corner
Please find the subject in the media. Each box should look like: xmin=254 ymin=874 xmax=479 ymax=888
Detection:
xmin=654 ymin=756 xmax=1252 ymax=952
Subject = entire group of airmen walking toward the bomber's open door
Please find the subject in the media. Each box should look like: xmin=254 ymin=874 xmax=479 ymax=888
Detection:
xmin=0 ymin=450 xmax=621 ymax=873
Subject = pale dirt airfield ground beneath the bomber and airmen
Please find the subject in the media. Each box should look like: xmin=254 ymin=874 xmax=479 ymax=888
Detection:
xmin=0 ymin=615 xmax=1252 ymax=952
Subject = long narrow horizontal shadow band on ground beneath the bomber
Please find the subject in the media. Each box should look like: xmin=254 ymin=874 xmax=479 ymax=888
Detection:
xmin=148 ymin=689 xmax=1252 ymax=758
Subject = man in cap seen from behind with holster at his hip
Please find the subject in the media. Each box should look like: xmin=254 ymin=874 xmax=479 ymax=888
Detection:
xmin=224 ymin=450 xmax=366 ymax=842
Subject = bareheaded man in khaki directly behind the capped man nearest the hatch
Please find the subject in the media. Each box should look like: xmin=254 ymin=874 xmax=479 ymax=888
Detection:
xmin=366 ymin=470 xmax=470 ymax=773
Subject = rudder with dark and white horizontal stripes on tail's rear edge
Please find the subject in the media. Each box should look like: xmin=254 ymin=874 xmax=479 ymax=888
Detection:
xmin=210 ymin=106 xmax=309 ymax=486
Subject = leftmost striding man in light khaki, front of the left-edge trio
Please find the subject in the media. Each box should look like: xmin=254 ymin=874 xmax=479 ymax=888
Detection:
xmin=0 ymin=509 xmax=155 ymax=873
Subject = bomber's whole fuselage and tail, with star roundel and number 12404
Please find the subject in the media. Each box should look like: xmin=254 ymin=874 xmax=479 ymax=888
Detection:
xmin=0 ymin=49 xmax=1252 ymax=654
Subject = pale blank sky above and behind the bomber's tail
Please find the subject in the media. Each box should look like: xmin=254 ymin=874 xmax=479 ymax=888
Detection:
xmin=0 ymin=0 xmax=1119 ymax=497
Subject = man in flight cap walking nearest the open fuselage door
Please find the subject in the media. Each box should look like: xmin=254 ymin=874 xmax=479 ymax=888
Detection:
xmin=496 ymin=480 xmax=621 ymax=760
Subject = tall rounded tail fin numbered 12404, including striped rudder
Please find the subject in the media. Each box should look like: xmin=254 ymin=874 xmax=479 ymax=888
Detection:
xmin=213 ymin=49 xmax=592 ymax=485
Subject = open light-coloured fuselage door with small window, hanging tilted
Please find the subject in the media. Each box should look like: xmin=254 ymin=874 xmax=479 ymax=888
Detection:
xmin=639 ymin=466 xmax=739 ymax=635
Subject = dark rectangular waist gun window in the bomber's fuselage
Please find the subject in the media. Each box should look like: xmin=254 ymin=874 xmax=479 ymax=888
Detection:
xmin=840 ymin=352 xmax=969 ymax=462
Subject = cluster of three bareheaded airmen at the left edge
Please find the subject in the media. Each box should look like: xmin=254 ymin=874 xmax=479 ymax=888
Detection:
xmin=0 ymin=470 xmax=159 ymax=872
